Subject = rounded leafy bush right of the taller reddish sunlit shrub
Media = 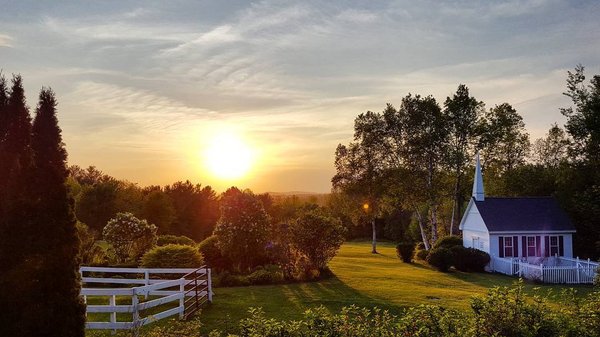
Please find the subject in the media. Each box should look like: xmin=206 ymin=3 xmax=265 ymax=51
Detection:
xmin=289 ymin=209 xmax=345 ymax=269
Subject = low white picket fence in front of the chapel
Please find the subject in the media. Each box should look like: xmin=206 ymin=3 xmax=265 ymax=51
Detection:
xmin=490 ymin=256 xmax=600 ymax=284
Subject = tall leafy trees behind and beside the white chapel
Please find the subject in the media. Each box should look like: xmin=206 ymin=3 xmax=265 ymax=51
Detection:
xmin=332 ymin=65 xmax=600 ymax=258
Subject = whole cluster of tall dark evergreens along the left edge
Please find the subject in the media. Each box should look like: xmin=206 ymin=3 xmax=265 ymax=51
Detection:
xmin=0 ymin=80 xmax=85 ymax=336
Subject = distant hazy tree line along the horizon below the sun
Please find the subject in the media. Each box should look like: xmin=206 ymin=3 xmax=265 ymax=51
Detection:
xmin=67 ymin=165 xmax=324 ymax=242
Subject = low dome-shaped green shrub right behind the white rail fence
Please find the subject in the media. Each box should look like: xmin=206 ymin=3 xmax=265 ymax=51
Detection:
xmin=141 ymin=244 xmax=204 ymax=268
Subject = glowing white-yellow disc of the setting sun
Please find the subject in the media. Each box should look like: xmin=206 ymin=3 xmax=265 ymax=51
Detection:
xmin=204 ymin=133 xmax=254 ymax=179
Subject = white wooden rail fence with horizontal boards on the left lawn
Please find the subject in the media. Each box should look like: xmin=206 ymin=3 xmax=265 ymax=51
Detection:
xmin=80 ymin=267 xmax=213 ymax=330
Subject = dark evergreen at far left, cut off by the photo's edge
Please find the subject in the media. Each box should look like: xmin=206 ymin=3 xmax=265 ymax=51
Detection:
xmin=0 ymin=75 xmax=34 ymax=336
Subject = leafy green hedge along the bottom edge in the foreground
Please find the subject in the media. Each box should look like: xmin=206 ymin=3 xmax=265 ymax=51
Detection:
xmin=209 ymin=282 xmax=600 ymax=337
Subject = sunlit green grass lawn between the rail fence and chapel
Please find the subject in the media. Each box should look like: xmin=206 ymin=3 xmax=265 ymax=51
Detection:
xmin=84 ymin=242 xmax=593 ymax=335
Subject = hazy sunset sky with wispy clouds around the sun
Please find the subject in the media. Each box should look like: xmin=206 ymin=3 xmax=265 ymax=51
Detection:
xmin=0 ymin=0 xmax=600 ymax=192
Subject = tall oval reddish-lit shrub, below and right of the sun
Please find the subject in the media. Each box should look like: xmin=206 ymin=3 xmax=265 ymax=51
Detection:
xmin=214 ymin=189 xmax=270 ymax=270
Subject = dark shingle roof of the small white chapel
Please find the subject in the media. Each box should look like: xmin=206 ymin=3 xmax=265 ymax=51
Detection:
xmin=475 ymin=197 xmax=575 ymax=232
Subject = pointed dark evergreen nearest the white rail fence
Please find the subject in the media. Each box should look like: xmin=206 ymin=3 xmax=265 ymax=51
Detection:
xmin=26 ymin=89 xmax=85 ymax=337
